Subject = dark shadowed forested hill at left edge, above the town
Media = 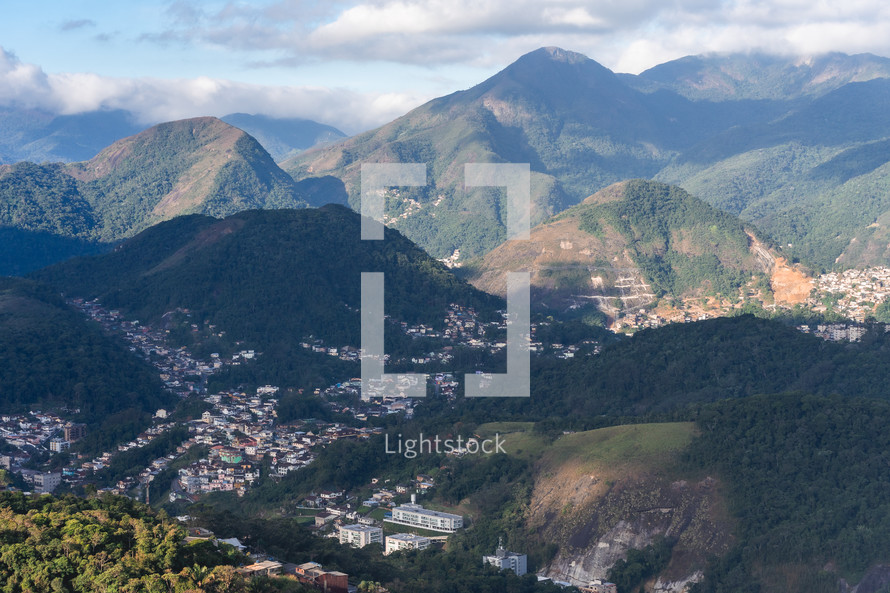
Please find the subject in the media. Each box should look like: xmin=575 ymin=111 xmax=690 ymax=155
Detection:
xmin=0 ymin=278 xmax=175 ymax=449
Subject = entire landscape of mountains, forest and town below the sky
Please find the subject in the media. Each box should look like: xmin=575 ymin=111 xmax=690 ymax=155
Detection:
xmin=0 ymin=47 xmax=890 ymax=593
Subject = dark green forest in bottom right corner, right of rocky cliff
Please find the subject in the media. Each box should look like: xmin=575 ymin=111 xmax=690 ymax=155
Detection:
xmin=687 ymin=394 xmax=890 ymax=593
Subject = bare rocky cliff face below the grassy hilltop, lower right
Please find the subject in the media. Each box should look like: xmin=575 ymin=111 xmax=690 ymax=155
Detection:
xmin=530 ymin=474 xmax=732 ymax=593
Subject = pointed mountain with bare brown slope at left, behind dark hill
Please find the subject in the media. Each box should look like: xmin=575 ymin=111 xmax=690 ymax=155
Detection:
xmin=0 ymin=117 xmax=330 ymax=268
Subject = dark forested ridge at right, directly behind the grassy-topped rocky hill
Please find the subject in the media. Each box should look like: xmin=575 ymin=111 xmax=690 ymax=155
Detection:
xmin=429 ymin=315 xmax=890 ymax=429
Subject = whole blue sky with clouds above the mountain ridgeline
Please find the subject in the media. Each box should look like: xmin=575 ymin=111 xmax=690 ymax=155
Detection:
xmin=0 ymin=0 xmax=890 ymax=133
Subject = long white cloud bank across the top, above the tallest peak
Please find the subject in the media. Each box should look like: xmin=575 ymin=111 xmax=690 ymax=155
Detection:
xmin=147 ymin=0 xmax=890 ymax=71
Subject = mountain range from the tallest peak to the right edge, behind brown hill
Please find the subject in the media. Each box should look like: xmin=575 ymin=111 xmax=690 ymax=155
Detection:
xmin=282 ymin=48 xmax=890 ymax=266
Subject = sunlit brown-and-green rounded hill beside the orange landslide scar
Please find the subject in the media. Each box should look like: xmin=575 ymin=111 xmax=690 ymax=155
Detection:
xmin=470 ymin=180 xmax=776 ymax=316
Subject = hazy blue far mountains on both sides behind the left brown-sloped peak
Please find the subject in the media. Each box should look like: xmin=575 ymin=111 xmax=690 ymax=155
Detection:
xmin=0 ymin=106 xmax=345 ymax=165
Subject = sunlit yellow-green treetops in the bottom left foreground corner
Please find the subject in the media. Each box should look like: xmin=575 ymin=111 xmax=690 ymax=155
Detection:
xmin=0 ymin=492 xmax=253 ymax=593
